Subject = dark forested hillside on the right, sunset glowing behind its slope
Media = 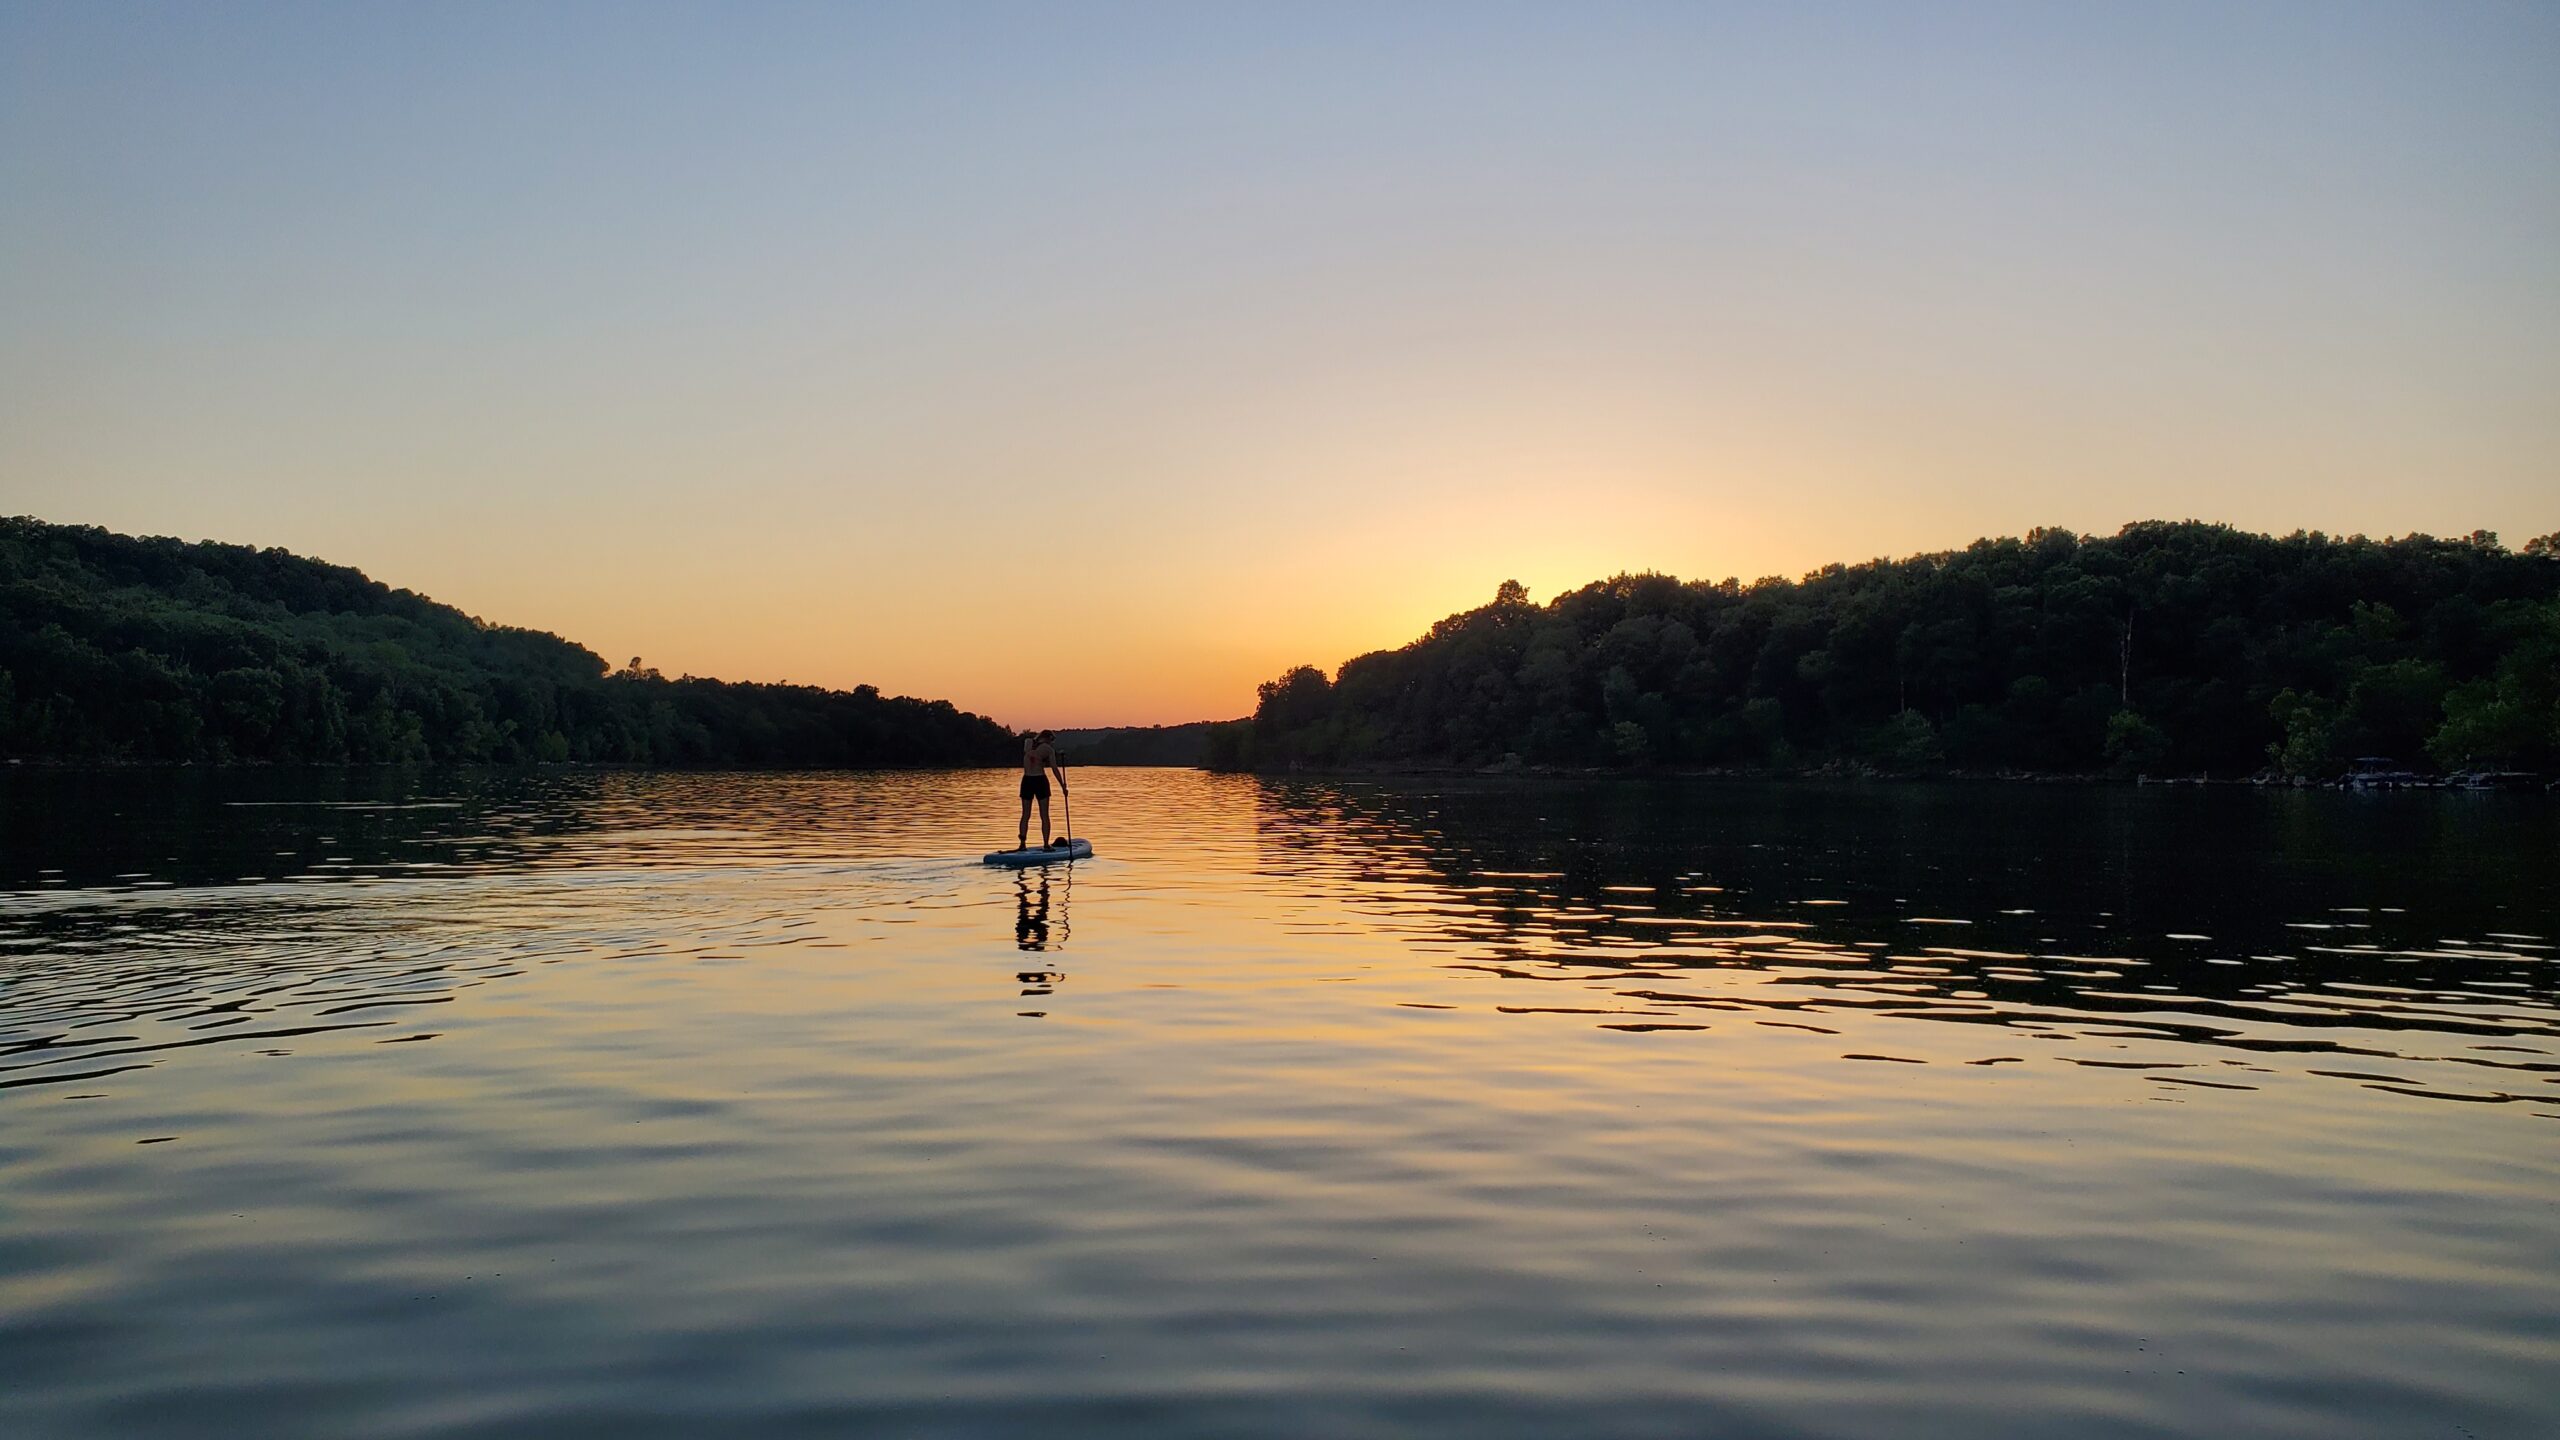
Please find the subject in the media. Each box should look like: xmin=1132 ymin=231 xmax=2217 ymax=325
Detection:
xmin=1213 ymin=523 xmax=2560 ymax=779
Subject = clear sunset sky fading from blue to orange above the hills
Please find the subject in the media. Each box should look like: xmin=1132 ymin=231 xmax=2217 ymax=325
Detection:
xmin=0 ymin=0 xmax=2560 ymax=725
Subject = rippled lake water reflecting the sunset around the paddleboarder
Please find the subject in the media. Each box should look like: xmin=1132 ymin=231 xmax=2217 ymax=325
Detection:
xmin=0 ymin=771 xmax=2560 ymax=1440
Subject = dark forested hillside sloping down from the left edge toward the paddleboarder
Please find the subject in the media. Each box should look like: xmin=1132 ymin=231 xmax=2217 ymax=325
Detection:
xmin=0 ymin=518 xmax=1014 ymax=766
